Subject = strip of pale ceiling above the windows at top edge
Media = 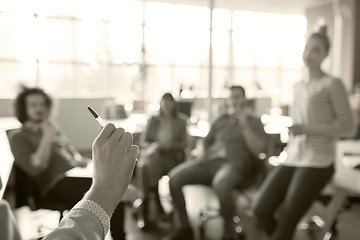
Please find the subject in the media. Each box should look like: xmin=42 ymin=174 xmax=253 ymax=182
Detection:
xmin=144 ymin=0 xmax=334 ymax=14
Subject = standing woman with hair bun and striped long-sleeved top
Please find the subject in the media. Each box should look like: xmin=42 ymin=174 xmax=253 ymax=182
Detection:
xmin=253 ymin=26 xmax=355 ymax=240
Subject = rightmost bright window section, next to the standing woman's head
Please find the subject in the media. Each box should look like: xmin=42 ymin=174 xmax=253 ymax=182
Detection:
xmin=232 ymin=11 xmax=306 ymax=103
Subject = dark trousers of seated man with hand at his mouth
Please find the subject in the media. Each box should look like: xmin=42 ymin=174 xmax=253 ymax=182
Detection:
xmin=169 ymin=158 xmax=245 ymax=233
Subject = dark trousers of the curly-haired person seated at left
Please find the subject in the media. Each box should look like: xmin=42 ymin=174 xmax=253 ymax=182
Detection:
xmin=46 ymin=178 xmax=125 ymax=240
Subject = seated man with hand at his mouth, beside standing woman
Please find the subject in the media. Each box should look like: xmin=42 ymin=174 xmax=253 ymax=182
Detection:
xmin=165 ymin=86 xmax=266 ymax=240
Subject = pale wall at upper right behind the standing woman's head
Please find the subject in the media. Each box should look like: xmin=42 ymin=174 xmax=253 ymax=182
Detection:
xmin=305 ymin=0 xmax=360 ymax=92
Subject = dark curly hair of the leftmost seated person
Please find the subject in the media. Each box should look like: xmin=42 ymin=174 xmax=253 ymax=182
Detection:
xmin=14 ymin=86 xmax=53 ymax=123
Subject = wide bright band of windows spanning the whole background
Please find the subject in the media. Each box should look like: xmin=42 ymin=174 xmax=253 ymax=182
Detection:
xmin=0 ymin=0 xmax=306 ymax=107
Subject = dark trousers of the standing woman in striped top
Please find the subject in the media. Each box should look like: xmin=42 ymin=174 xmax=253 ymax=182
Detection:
xmin=253 ymin=165 xmax=334 ymax=240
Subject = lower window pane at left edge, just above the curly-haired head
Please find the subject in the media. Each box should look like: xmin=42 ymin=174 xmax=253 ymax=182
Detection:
xmin=0 ymin=61 xmax=36 ymax=98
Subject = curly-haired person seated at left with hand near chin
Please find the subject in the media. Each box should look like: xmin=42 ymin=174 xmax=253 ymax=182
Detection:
xmin=10 ymin=88 xmax=125 ymax=240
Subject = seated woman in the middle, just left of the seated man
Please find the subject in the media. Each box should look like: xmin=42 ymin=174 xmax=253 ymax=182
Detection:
xmin=137 ymin=93 xmax=187 ymax=229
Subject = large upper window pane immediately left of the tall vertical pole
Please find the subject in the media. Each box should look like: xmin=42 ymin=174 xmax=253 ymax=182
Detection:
xmin=145 ymin=3 xmax=209 ymax=65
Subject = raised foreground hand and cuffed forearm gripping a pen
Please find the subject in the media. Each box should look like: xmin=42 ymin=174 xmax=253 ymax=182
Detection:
xmin=45 ymin=123 xmax=139 ymax=240
